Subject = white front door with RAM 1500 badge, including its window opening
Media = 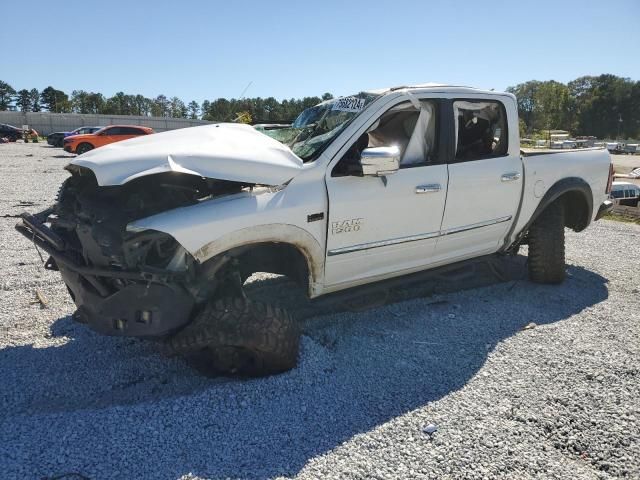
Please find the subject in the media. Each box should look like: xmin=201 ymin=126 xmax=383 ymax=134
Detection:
xmin=325 ymin=99 xmax=447 ymax=291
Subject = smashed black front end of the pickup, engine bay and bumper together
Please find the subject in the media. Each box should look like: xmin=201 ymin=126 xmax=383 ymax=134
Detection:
xmin=16 ymin=165 xmax=253 ymax=337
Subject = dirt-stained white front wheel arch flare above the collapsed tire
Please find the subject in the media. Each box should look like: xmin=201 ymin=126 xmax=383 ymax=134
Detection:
xmin=193 ymin=223 xmax=324 ymax=298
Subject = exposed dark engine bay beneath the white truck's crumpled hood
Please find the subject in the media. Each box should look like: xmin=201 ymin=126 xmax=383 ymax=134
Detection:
xmin=55 ymin=165 xmax=253 ymax=270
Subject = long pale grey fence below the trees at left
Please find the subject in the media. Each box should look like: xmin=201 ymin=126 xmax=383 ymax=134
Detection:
xmin=0 ymin=112 xmax=211 ymax=136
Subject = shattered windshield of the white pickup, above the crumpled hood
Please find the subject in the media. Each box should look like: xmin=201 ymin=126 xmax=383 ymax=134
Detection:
xmin=263 ymin=92 xmax=379 ymax=162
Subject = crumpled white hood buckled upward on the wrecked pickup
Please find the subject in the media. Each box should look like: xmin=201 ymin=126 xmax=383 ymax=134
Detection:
xmin=71 ymin=123 xmax=302 ymax=186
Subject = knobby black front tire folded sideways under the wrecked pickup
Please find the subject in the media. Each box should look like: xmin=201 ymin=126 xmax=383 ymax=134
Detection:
xmin=168 ymin=298 xmax=300 ymax=377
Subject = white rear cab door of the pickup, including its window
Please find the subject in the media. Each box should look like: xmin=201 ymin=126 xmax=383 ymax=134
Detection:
xmin=434 ymin=96 xmax=524 ymax=262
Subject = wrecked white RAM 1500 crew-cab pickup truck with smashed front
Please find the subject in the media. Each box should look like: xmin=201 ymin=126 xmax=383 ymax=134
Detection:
xmin=16 ymin=84 xmax=612 ymax=374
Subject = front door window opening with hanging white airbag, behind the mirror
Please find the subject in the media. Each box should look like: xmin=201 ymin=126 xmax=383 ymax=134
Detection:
xmin=331 ymin=101 xmax=436 ymax=177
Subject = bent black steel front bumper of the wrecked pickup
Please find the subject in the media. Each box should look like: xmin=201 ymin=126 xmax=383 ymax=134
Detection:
xmin=16 ymin=211 xmax=194 ymax=337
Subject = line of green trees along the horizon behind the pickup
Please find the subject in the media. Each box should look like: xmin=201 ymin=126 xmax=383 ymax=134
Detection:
xmin=0 ymin=74 xmax=640 ymax=138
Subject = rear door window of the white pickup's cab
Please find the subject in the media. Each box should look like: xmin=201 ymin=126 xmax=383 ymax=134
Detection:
xmin=453 ymin=100 xmax=509 ymax=162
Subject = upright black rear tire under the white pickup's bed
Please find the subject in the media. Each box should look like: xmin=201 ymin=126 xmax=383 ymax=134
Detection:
xmin=528 ymin=202 xmax=566 ymax=283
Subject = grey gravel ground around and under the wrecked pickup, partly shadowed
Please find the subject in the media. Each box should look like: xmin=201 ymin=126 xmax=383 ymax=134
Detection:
xmin=0 ymin=144 xmax=640 ymax=479
